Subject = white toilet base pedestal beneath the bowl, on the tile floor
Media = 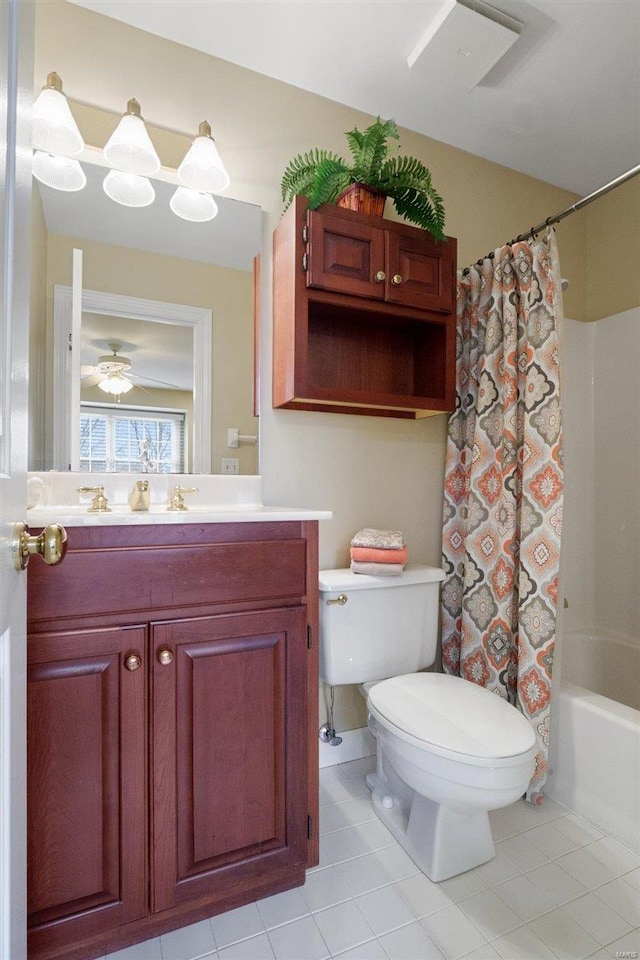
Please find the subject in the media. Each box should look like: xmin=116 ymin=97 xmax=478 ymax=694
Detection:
xmin=367 ymin=763 xmax=496 ymax=882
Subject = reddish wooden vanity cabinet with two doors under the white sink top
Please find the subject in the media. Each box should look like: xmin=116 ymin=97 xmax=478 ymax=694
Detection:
xmin=28 ymin=521 xmax=318 ymax=960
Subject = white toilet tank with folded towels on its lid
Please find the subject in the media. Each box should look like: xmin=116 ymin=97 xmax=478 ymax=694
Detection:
xmin=319 ymin=564 xmax=444 ymax=685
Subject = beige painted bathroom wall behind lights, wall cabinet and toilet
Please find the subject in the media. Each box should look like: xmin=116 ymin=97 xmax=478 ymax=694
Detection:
xmin=36 ymin=0 xmax=608 ymax=729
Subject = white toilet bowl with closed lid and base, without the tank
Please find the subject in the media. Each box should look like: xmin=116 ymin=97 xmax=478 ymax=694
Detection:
xmin=367 ymin=673 xmax=536 ymax=881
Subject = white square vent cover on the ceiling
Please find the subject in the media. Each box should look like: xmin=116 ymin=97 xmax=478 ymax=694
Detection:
xmin=407 ymin=0 xmax=522 ymax=91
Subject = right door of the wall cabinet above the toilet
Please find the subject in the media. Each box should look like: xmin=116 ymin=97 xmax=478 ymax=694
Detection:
xmin=385 ymin=230 xmax=456 ymax=313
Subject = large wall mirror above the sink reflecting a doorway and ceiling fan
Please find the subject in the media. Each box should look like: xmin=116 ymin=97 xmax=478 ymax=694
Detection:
xmin=30 ymin=162 xmax=261 ymax=473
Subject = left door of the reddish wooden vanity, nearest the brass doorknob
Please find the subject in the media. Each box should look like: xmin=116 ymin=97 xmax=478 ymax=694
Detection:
xmin=27 ymin=626 xmax=148 ymax=955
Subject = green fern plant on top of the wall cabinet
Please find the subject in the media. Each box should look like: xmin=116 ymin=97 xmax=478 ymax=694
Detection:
xmin=280 ymin=117 xmax=444 ymax=240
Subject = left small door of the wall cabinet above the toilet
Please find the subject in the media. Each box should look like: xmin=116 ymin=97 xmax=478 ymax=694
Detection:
xmin=307 ymin=210 xmax=385 ymax=300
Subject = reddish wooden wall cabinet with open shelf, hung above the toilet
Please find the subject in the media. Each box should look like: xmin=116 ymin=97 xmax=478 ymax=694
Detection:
xmin=273 ymin=197 xmax=456 ymax=418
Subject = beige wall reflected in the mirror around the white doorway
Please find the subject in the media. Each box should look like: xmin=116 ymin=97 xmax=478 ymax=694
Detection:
xmin=46 ymin=234 xmax=258 ymax=473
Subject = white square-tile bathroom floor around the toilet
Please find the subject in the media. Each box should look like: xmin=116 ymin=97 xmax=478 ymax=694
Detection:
xmin=107 ymin=758 xmax=640 ymax=960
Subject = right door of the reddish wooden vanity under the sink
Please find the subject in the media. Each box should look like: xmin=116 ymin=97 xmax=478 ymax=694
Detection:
xmin=151 ymin=607 xmax=307 ymax=911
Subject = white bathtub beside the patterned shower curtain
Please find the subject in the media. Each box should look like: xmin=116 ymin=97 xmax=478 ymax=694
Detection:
xmin=546 ymin=634 xmax=640 ymax=854
